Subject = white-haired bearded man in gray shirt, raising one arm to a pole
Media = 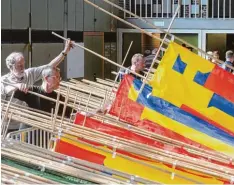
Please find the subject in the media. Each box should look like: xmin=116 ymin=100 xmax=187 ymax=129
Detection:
xmin=1 ymin=40 xmax=73 ymax=99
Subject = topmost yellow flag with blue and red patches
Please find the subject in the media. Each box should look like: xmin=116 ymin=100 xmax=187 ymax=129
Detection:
xmin=151 ymin=43 xmax=234 ymax=135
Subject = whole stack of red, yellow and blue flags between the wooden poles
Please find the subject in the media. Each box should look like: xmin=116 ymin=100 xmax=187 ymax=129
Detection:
xmin=55 ymin=42 xmax=234 ymax=184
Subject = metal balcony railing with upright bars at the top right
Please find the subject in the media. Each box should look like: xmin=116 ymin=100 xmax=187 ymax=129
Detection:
xmin=119 ymin=0 xmax=234 ymax=19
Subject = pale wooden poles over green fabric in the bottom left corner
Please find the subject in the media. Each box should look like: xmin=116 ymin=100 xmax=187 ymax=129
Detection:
xmin=1 ymin=138 xmax=155 ymax=184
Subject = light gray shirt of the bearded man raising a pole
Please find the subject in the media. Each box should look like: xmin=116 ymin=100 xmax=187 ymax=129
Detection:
xmin=1 ymin=65 xmax=48 ymax=97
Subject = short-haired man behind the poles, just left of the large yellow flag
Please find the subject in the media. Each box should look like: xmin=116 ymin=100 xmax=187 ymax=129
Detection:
xmin=119 ymin=53 xmax=145 ymax=80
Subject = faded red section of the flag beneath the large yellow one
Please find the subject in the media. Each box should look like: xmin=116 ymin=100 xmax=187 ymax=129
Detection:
xmin=109 ymin=75 xmax=209 ymax=149
